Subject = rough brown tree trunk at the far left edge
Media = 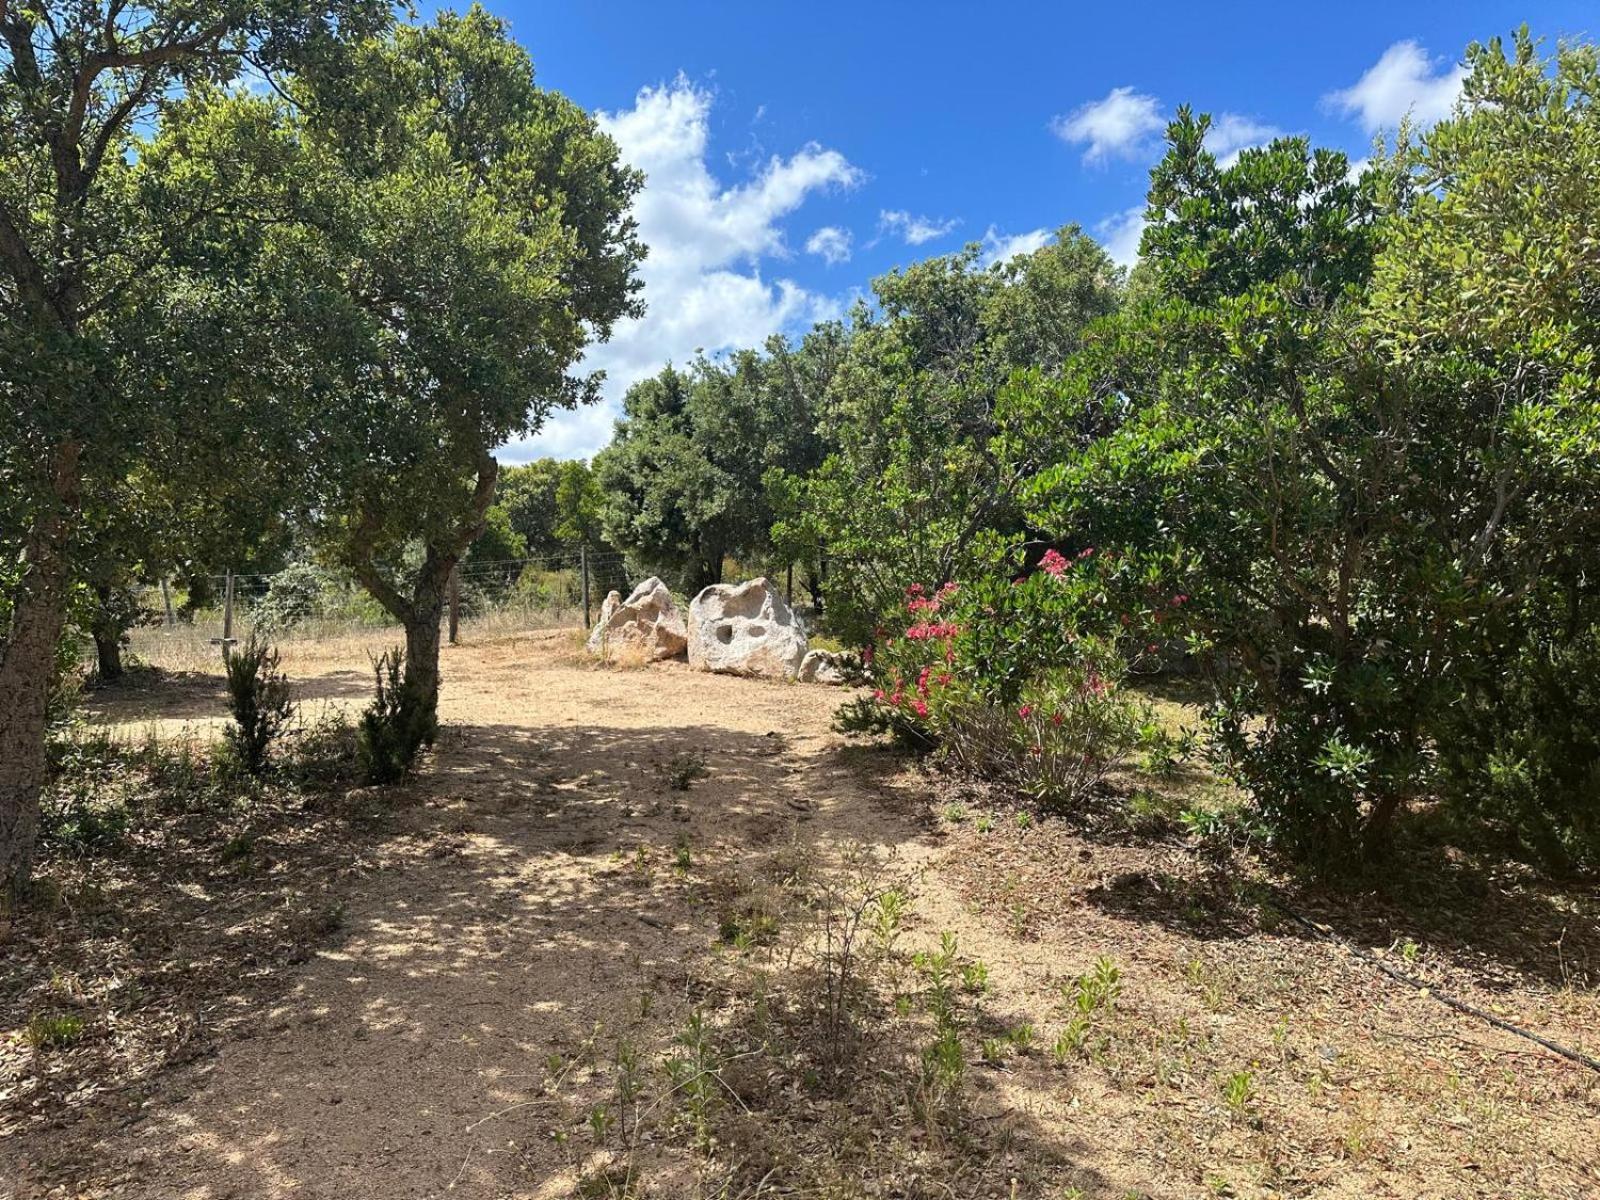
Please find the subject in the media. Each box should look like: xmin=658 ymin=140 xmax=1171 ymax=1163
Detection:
xmin=0 ymin=443 xmax=78 ymax=912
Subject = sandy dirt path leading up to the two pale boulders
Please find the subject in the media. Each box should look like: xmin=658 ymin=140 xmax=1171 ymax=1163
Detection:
xmin=37 ymin=638 xmax=934 ymax=1200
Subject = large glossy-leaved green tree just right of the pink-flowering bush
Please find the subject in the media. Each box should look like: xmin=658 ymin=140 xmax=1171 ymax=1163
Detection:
xmin=1005 ymin=77 xmax=1594 ymax=861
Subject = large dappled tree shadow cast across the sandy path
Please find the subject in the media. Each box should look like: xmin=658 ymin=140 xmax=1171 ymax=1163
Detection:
xmin=9 ymin=725 xmax=1098 ymax=1198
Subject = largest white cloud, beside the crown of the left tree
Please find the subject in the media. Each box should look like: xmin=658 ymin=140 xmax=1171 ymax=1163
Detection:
xmin=502 ymin=75 xmax=862 ymax=461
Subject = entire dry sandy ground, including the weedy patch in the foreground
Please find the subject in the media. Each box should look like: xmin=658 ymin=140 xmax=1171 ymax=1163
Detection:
xmin=0 ymin=632 xmax=1600 ymax=1200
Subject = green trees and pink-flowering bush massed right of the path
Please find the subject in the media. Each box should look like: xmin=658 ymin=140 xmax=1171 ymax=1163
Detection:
xmin=598 ymin=34 xmax=1600 ymax=867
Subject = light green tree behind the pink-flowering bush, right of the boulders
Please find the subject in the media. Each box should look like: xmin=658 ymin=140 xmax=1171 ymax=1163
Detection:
xmin=773 ymin=236 xmax=1120 ymax=645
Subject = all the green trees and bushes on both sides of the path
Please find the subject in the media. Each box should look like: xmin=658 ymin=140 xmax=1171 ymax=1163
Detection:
xmin=0 ymin=16 xmax=1600 ymax=902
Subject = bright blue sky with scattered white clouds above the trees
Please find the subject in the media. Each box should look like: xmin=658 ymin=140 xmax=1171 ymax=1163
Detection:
xmin=486 ymin=0 xmax=1600 ymax=461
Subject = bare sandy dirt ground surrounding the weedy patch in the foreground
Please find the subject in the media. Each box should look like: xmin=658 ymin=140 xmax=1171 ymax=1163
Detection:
xmin=0 ymin=634 xmax=1600 ymax=1200
